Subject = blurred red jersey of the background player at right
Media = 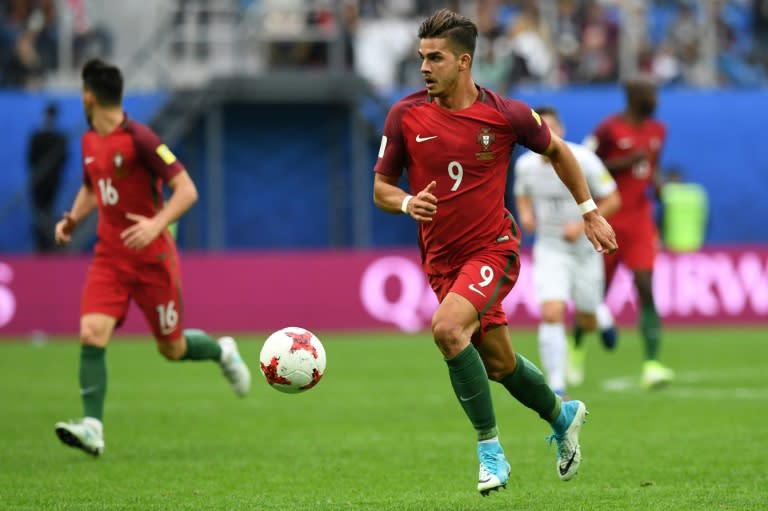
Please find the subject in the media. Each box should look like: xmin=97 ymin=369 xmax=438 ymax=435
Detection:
xmin=594 ymin=114 xmax=667 ymax=223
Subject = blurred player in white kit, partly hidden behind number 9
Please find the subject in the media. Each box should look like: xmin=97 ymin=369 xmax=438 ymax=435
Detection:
xmin=514 ymin=107 xmax=621 ymax=395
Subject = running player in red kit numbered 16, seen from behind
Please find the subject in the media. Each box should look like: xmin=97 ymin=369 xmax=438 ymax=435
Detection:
xmin=55 ymin=59 xmax=251 ymax=456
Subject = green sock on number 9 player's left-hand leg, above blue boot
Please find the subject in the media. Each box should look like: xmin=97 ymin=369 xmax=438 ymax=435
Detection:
xmin=446 ymin=344 xmax=499 ymax=440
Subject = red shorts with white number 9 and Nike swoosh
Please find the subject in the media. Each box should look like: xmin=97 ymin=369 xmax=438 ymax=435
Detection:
xmin=428 ymin=250 xmax=520 ymax=343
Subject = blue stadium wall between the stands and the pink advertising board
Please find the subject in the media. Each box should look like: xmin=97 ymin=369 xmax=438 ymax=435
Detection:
xmin=0 ymin=87 xmax=768 ymax=252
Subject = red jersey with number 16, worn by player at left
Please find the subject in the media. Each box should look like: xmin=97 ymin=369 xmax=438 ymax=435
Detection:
xmin=82 ymin=117 xmax=184 ymax=261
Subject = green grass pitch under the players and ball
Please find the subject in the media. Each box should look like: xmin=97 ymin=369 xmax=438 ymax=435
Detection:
xmin=0 ymin=328 xmax=768 ymax=511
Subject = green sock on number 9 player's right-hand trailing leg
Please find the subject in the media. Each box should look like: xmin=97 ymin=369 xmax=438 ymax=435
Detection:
xmin=501 ymin=353 xmax=562 ymax=422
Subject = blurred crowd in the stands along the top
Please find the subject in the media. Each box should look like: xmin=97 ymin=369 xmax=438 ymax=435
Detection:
xmin=0 ymin=0 xmax=768 ymax=90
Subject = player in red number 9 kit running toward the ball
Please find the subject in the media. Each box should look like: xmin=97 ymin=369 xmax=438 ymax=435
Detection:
xmin=373 ymin=9 xmax=616 ymax=495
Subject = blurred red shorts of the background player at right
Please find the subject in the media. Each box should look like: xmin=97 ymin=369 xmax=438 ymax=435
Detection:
xmin=605 ymin=217 xmax=659 ymax=282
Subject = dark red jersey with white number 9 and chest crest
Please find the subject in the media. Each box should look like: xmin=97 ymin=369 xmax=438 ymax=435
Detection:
xmin=375 ymin=88 xmax=551 ymax=274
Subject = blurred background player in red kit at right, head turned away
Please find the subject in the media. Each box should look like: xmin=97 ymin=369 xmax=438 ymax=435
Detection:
xmin=590 ymin=78 xmax=674 ymax=388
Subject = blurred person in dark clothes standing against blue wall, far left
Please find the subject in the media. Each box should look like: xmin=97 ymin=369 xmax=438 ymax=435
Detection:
xmin=27 ymin=103 xmax=67 ymax=252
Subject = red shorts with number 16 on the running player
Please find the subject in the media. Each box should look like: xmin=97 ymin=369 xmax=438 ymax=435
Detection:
xmin=80 ymin=252 xmax=184 ymax=342
